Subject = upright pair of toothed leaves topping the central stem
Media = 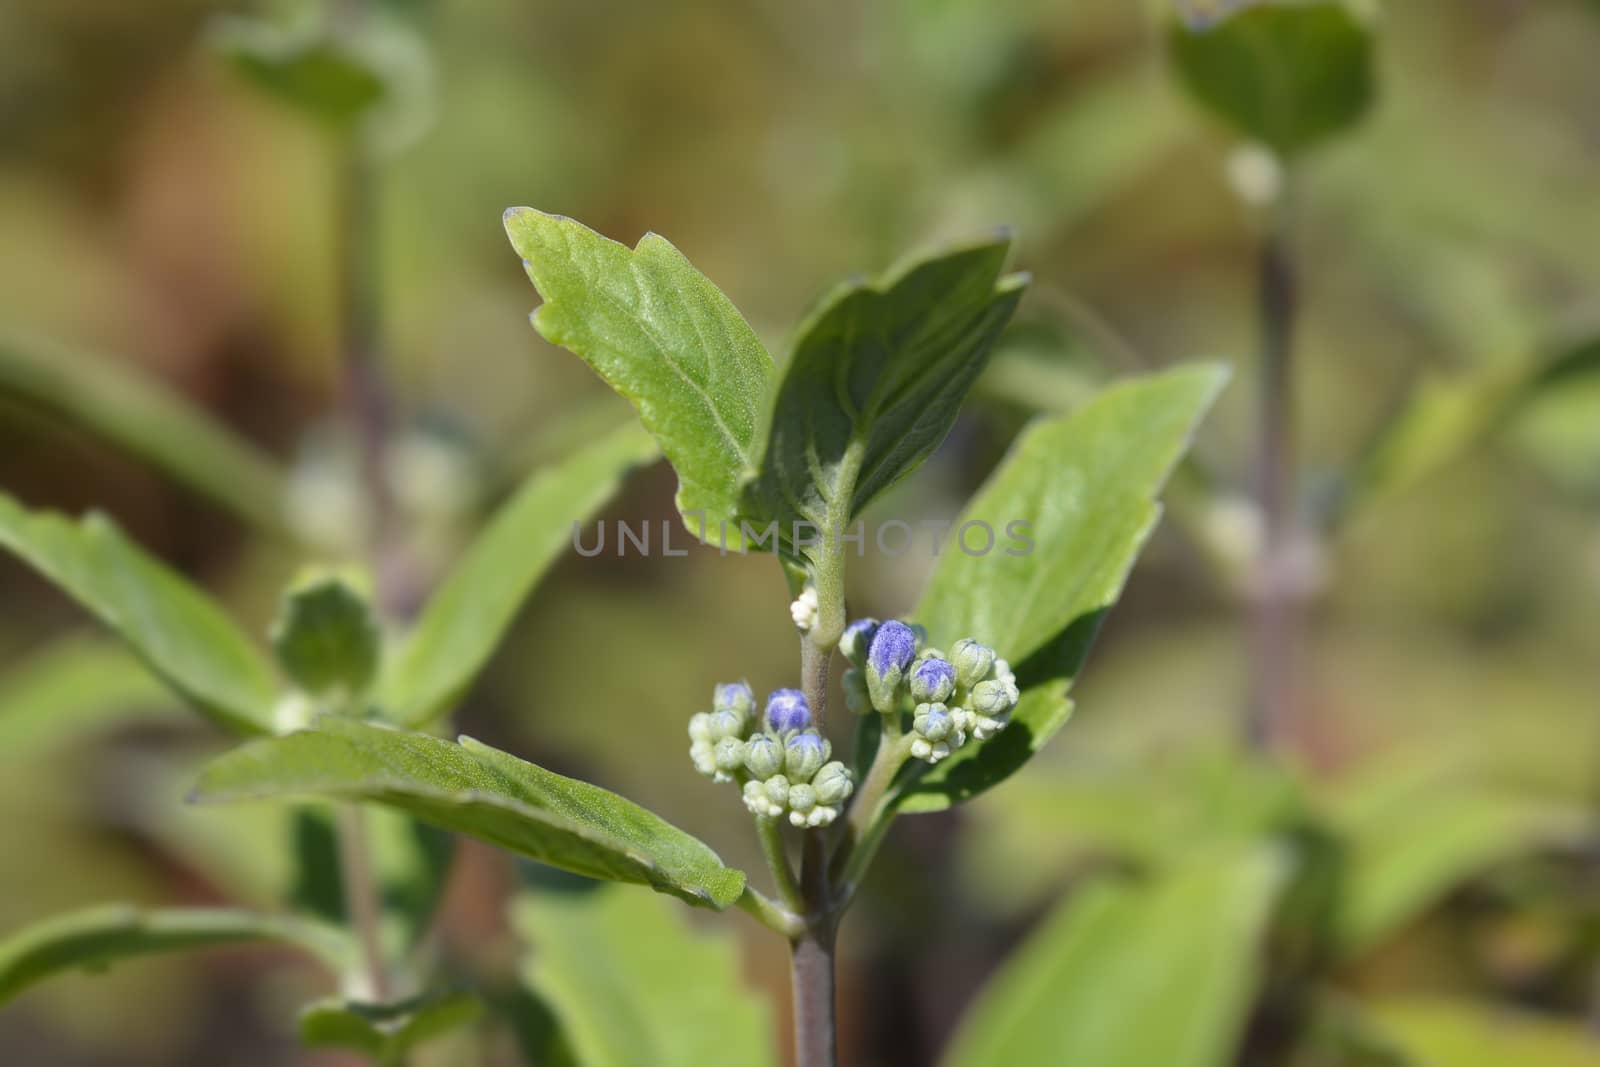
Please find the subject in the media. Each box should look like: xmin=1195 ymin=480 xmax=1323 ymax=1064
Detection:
xmin=506 ymin=208 xmax=1026 ymax=558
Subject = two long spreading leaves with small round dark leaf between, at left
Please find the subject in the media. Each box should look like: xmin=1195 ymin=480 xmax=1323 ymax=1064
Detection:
xmin=0 ymin=427 xmax=654 ymax=734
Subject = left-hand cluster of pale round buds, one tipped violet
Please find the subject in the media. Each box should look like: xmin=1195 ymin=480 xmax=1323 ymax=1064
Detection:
xmin=690 ymin=681 xmax=856 ymax=827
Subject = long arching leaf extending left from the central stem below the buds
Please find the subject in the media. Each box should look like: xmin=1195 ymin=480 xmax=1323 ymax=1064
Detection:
xmin=195 ymin=718 xmax=744 ymax=910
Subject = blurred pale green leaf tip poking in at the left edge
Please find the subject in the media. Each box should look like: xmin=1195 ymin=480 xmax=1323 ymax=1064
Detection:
xmin=0 ymin=633 xmax=178 ymax=766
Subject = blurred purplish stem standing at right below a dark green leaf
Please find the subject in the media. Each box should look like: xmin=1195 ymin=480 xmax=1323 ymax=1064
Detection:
xmin=1248 ymin=219 xmax=1302 ymax=747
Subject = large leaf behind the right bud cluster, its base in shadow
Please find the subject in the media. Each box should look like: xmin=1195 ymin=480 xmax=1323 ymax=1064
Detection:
xmin=901 ymin=366 xmax=1227 ymax=811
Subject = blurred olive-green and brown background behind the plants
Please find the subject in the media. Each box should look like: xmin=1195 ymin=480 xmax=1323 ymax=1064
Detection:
xmin=0 ymin=0 xmax=1600 ymax=1067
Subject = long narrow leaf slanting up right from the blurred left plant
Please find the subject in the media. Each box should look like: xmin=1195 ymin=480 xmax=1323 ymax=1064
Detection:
xmin=379 ymin=426 xmax=654 ymax=726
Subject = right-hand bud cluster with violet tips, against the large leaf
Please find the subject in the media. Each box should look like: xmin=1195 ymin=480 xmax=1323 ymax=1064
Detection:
xmin=840 ymin=619 xmax=1021 ymax=763
